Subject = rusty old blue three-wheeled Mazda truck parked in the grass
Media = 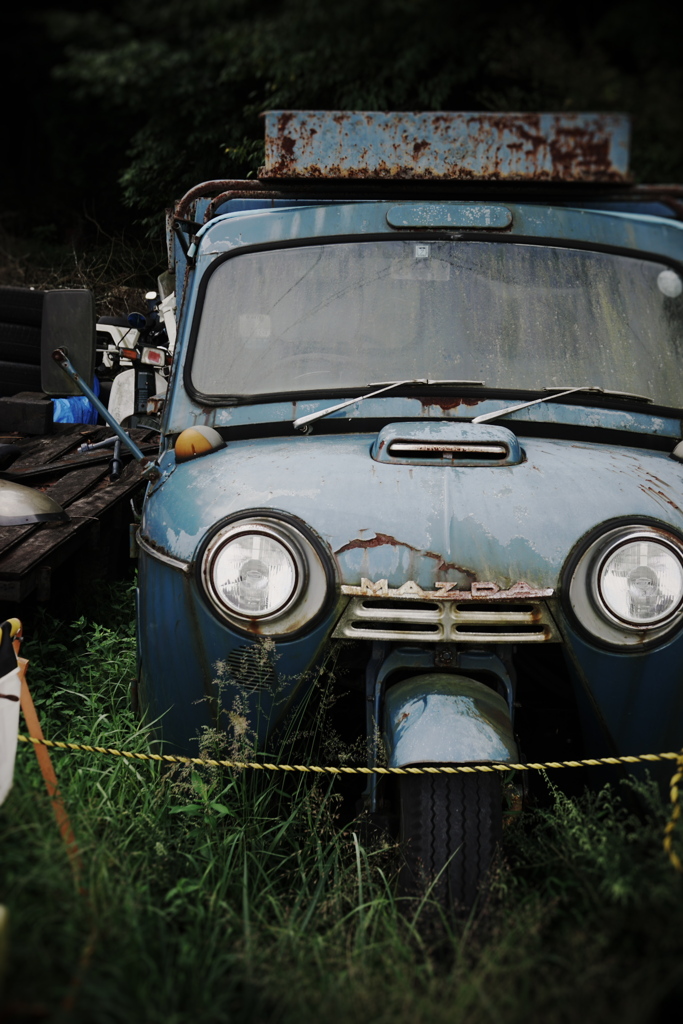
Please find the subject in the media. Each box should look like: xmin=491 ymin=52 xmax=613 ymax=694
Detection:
xmin=46 ymin=111 xmax=683 ymax=905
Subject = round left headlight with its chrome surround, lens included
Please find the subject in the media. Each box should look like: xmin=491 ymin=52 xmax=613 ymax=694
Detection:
xmin=198 ymin=513 xmax=334 ymax=636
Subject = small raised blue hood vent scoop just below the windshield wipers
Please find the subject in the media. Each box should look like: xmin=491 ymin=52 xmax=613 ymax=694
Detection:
xmin=372 ymin=422 xmax=523 ymax=466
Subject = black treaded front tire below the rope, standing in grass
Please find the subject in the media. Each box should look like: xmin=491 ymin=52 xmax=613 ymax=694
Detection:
xmin=399 ymin=772 xmax=503 ymax=910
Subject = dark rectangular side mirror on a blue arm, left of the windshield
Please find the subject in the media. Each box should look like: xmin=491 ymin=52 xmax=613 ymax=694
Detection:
xmin=40 ymin=288 xmax=95 ymax=396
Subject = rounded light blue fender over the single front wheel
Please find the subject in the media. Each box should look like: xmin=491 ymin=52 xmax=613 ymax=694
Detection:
xmin=384 ymin=673 xmax=518 ymax=768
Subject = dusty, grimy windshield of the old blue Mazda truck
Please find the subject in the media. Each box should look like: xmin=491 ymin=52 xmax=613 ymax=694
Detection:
xmin=191 ymin=240 xmax=683 ymax=407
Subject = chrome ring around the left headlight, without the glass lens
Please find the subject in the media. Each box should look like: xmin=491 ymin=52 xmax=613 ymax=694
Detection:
xmin=197 ymin=510 xmax=334 ymax=639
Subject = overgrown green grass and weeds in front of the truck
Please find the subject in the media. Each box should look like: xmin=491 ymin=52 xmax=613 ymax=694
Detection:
xmin=0 ymin=586 xmax=683 ymax=1024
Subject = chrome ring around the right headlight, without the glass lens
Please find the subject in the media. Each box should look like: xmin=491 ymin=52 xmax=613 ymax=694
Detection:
xmin=566 ymin=520 xmax=683 ymax=650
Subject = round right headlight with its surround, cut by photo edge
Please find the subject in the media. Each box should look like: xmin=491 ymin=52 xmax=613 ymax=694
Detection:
xmin=568 ymin=525 xmax=683 ymax=646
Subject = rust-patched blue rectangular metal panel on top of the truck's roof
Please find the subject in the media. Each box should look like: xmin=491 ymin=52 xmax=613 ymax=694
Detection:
xmin=259 ymin=111 xmax=630 ymax=183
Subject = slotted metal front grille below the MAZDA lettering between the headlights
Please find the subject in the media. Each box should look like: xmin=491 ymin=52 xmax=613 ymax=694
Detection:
xmin=333 ymin=597 xmax=560 ymax=643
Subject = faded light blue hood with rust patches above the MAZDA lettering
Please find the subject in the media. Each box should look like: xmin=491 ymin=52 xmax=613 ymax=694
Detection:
xmin=142 ymin=425 xmax=683 ymax=590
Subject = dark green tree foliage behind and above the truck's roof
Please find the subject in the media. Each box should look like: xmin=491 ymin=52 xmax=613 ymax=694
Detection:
xmin=40 ymin=0 xmax=683 ymax=225
